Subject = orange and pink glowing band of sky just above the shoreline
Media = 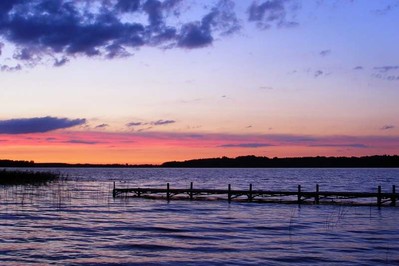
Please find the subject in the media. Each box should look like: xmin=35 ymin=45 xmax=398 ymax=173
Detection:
xmin=0 ymin=131 xmax=399 ymax=164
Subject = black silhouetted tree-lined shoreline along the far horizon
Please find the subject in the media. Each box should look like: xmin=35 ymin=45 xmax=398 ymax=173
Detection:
xmin=0 ymin=155 xmax=399 ymax=168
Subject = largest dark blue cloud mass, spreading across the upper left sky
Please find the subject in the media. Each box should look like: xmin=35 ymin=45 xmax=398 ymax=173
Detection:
xmin=0 ymin=0 xmax=240 ymax=67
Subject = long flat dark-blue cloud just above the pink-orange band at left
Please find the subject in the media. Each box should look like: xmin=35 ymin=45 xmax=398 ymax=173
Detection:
xmin=0 ymin=116 xmax=86 ymax=134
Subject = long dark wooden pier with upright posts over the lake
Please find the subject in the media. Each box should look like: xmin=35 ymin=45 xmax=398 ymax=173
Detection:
xmin=112 ymin=182 xmax=399 ymax=207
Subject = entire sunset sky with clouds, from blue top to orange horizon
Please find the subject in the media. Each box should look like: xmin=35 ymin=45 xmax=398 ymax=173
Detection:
xmin=0 ymin=0 xmax=399 ymax=164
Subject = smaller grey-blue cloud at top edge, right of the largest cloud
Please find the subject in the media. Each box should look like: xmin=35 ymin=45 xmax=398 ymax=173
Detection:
xmin=248 ymin=0 xmax=298 ymax=29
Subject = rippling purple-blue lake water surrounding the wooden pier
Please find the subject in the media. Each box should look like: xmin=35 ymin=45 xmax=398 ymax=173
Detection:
xmin=0 ymin=169 xmax=399 ymax=265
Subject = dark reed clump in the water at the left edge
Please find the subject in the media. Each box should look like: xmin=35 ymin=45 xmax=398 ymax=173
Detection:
xmin=0 ymin=169 xmax=64 ymax=186
